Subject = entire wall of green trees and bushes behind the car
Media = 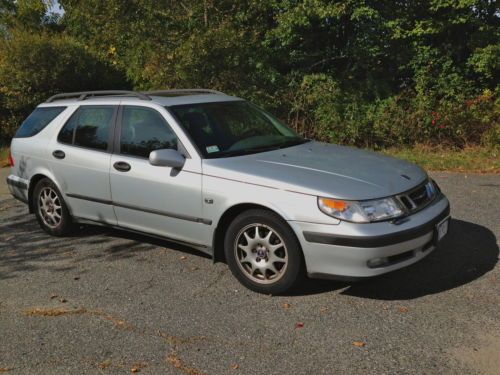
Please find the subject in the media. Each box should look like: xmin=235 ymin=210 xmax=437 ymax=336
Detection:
xmin=0 ymin=0 xmax=500 ymax=148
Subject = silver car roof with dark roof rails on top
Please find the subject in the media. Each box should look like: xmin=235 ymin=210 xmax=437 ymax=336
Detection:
xmin=41 ymin=89 xmax=242 ymax=107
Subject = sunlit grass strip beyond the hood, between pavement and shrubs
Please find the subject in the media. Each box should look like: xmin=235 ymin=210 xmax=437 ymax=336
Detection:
xmin=381 ymin=145 xmax=500 ymax=174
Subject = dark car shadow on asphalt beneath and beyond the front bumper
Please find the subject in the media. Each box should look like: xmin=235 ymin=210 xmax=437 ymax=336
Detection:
xmin=294 ymin=219 xmax=499 ymax=300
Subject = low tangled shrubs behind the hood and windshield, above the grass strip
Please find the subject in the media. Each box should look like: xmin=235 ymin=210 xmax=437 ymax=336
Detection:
xmin=281 ymin=74 xmax=500 ymax=148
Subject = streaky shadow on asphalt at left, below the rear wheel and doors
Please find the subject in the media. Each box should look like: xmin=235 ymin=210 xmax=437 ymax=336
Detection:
xmin=0 ymin=206 xmax=211 ymax=280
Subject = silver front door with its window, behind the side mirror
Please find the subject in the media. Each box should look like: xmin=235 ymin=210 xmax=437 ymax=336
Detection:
xmin=110 ymin=105 xmax=210 ymax=245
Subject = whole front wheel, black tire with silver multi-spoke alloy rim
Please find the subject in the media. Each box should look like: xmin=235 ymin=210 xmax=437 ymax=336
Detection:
xmin=224 ymin=209 xmax=305 ymax=294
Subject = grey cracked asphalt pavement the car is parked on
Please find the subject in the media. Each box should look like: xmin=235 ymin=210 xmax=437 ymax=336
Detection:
xmin=0 ymin=170 xmax=500 ymax=375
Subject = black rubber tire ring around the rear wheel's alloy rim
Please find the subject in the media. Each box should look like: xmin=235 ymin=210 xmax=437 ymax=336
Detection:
xmin=31 ymin=178 xmax=74 ymax=236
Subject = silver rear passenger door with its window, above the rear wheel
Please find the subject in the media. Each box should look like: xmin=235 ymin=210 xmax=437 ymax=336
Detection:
xmin=50 ymin=105 xmax=118 ymax=224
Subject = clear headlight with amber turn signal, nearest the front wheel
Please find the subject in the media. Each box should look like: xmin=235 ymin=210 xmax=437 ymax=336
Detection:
xmin=318 ymin=197 xmax=403 ymax=223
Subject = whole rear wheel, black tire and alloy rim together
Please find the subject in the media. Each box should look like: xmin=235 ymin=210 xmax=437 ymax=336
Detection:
xmin=32 ymin=178 xmax=73 ymax=236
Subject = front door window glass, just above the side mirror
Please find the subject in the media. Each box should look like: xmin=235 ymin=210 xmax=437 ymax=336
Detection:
xmin=120 ymin=106 xmax=177 ymax=158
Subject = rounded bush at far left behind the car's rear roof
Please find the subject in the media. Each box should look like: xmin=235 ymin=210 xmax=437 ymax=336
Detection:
xmin=0 ymin=31 xmax=128 ymax=142
